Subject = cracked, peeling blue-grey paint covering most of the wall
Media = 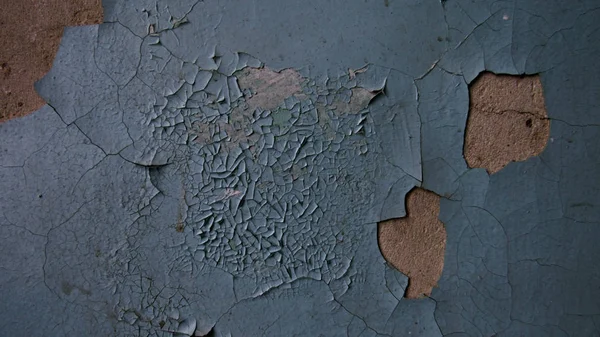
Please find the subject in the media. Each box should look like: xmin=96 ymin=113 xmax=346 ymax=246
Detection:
xmin=0 ymin=0 xmax=600 ymax=336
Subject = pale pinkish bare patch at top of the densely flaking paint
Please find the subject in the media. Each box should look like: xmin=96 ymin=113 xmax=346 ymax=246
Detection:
xmin=236 ymin=67 xmax=303 ymax=111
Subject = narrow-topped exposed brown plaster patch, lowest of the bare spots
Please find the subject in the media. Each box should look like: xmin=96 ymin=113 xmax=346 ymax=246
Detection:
xmin=378 ymin=188 xmax=446 ymax=298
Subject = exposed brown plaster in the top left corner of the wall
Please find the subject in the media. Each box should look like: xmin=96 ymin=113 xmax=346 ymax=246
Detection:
xmin=0 ymin=0 xmax=103 ymax=122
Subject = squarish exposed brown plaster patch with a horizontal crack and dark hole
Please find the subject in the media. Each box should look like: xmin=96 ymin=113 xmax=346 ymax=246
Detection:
xmin=464 ymin=72 xmax=550 ymax=174
